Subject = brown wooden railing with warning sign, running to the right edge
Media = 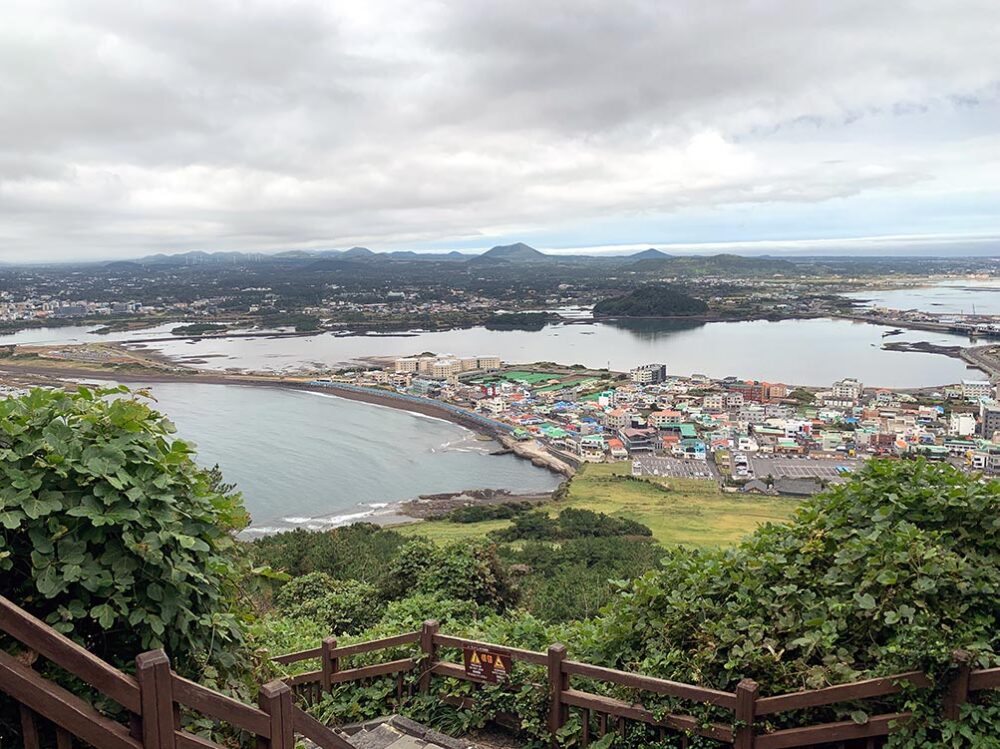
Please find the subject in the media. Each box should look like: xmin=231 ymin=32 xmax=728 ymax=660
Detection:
xmin=274 ymin=621 xmax=1000 ymax=749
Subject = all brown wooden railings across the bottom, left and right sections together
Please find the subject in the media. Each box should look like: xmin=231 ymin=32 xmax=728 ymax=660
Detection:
xmin=0 ymin=597 xmax=1000 ymax=749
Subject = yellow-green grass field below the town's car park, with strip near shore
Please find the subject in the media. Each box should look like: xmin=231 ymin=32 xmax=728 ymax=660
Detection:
xmin=397 ymin=463 xmax=798 ymax=546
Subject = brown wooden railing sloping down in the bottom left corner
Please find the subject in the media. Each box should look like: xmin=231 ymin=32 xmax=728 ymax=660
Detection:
xmin=0 ymin=596 xmax=351 ymax=749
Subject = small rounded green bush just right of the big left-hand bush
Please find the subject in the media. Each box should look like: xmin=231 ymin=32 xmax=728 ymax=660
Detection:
xmin=275 ymin=572 xmax=382 ymax=635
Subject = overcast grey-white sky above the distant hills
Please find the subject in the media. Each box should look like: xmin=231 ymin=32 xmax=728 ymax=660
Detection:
xmin=0 ymin=0 xmax=1000 ymax=261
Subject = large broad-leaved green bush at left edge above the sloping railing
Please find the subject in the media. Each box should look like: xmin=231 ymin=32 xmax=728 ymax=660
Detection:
xmin=0 ymin=388 xmax=248 ymax=671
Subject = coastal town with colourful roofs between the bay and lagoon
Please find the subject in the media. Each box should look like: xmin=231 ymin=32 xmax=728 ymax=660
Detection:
xmin=310 ymin=354 xmax=1000 ymax=496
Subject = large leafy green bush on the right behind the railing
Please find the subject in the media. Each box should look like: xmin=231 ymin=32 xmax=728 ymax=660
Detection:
xmin=588 ymin=460 xmax=1000 ymax=728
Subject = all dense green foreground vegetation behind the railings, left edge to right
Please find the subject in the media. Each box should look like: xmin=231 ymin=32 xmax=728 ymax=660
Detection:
xmin=0 ymin=390 xmax=1000 ymax=749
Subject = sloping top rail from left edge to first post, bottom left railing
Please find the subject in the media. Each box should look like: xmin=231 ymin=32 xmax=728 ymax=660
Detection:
xmin=0 ymin=596 xmax=140 ymax=713
